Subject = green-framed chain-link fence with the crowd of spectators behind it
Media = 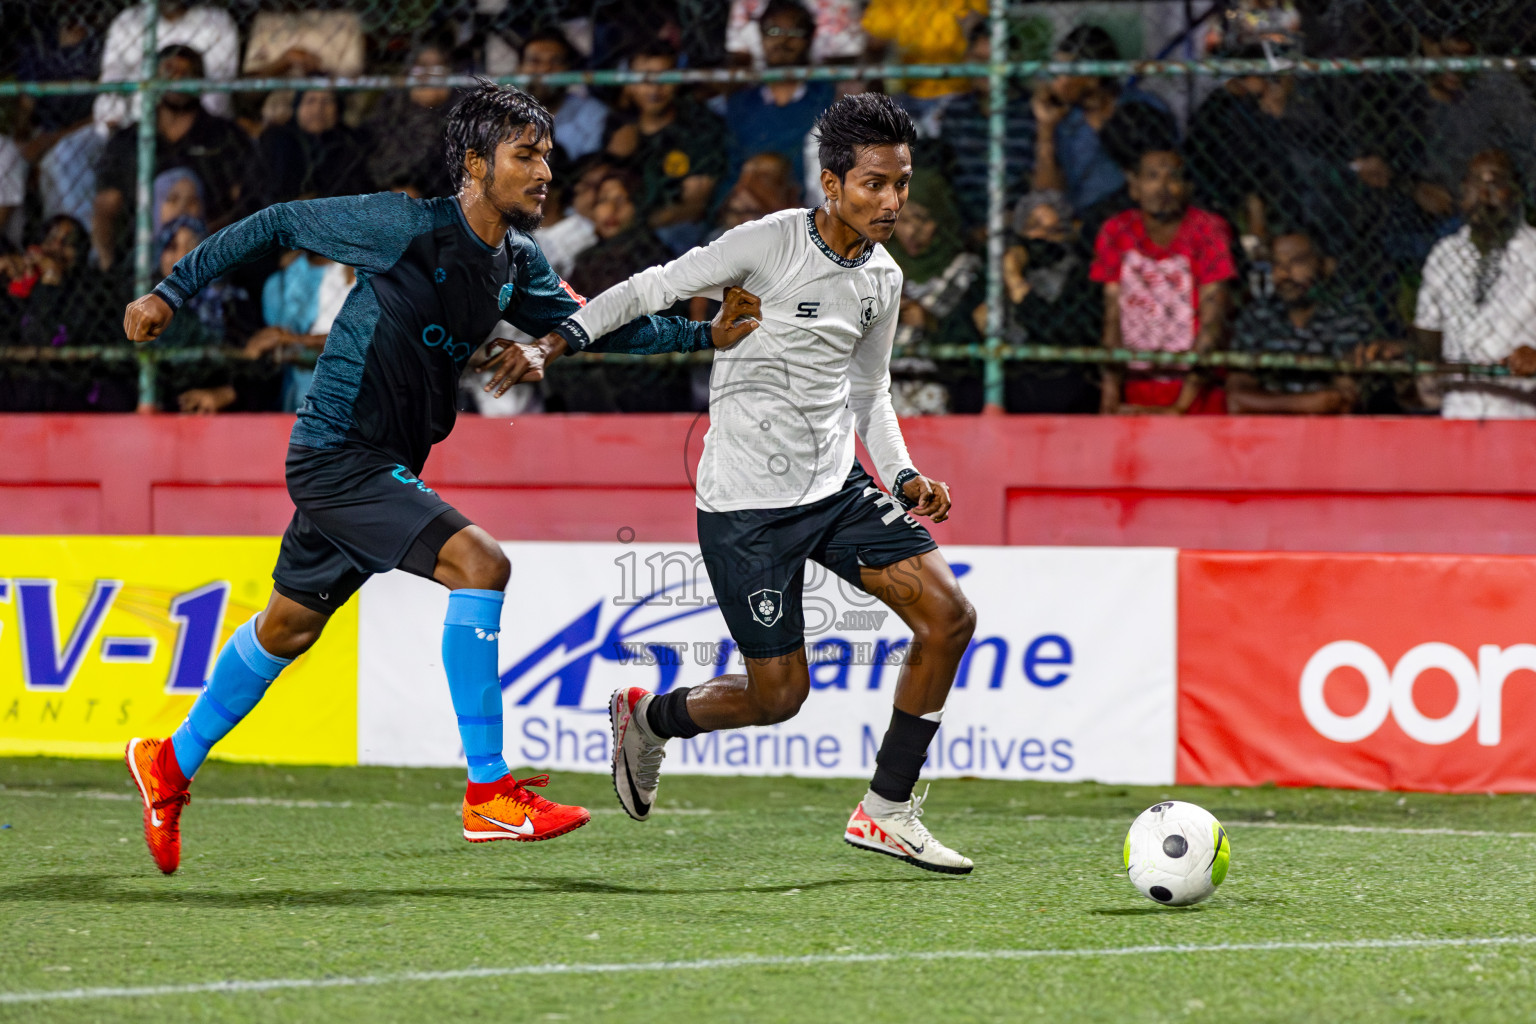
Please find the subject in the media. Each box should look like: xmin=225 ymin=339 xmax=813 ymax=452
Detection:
xmin=0 ymin=0 xmax=1536 ymax=416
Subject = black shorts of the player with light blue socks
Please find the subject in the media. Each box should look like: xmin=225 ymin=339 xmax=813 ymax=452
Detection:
xmin=272 ymin=445 xmax=470 ymax=614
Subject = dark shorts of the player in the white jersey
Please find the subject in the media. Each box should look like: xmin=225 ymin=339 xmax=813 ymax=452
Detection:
xmin=699 ymin=461 xmax=938 ymax=659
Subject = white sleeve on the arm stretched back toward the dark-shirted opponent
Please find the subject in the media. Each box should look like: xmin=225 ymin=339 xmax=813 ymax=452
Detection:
xmin=565 ymin=221 xmax=770 ymax=348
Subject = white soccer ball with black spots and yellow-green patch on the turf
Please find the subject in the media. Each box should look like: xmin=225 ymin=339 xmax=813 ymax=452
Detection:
xmin=1124 ymin=800 xmax=1232 ymax=907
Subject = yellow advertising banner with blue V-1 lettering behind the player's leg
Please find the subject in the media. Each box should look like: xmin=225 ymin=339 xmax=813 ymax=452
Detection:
xmin=0 ymin=537 xmax=358 ymax=765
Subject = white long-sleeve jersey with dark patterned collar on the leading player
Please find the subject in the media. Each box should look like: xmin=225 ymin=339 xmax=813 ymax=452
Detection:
xmin=565 ymin=210 xmax=912 ymax=511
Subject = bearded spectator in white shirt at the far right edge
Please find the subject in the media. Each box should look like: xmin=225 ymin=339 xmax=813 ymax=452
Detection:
xmin=1413 ymin=149 xmax=1536 ymax=419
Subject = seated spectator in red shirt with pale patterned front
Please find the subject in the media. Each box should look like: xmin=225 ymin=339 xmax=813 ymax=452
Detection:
xmin=1089 ymin=149 xmax=1236 ymax=416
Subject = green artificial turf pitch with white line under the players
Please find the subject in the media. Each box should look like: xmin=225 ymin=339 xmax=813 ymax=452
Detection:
xmin=0 ymin=758 xmax=1536 ymax=1024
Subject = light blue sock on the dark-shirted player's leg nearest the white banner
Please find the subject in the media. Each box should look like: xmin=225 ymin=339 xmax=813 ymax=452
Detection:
xmin=442 ymin=590 xmax=507 ymax=783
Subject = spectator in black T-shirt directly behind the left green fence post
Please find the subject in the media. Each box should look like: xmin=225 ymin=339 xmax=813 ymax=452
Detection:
xmin=91 ymin=46 xmax=260 ymax=270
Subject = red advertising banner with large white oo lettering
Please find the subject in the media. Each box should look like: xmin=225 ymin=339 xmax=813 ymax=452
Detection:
xmin=1177 ymin=551 xmax=1536 ymax=792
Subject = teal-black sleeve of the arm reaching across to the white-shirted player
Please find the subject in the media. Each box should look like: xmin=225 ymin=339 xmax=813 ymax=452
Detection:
xmin=505 ymin=239 xmax=713 ymax=355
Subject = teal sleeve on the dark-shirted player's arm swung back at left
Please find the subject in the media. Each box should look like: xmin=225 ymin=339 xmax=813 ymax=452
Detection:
xmin=155 ymin=192 xmax=432 ymax=309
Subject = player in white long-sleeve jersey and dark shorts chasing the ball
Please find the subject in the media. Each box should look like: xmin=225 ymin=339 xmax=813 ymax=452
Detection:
xmin=488 ymin=94 xmax=975 ymax=874
